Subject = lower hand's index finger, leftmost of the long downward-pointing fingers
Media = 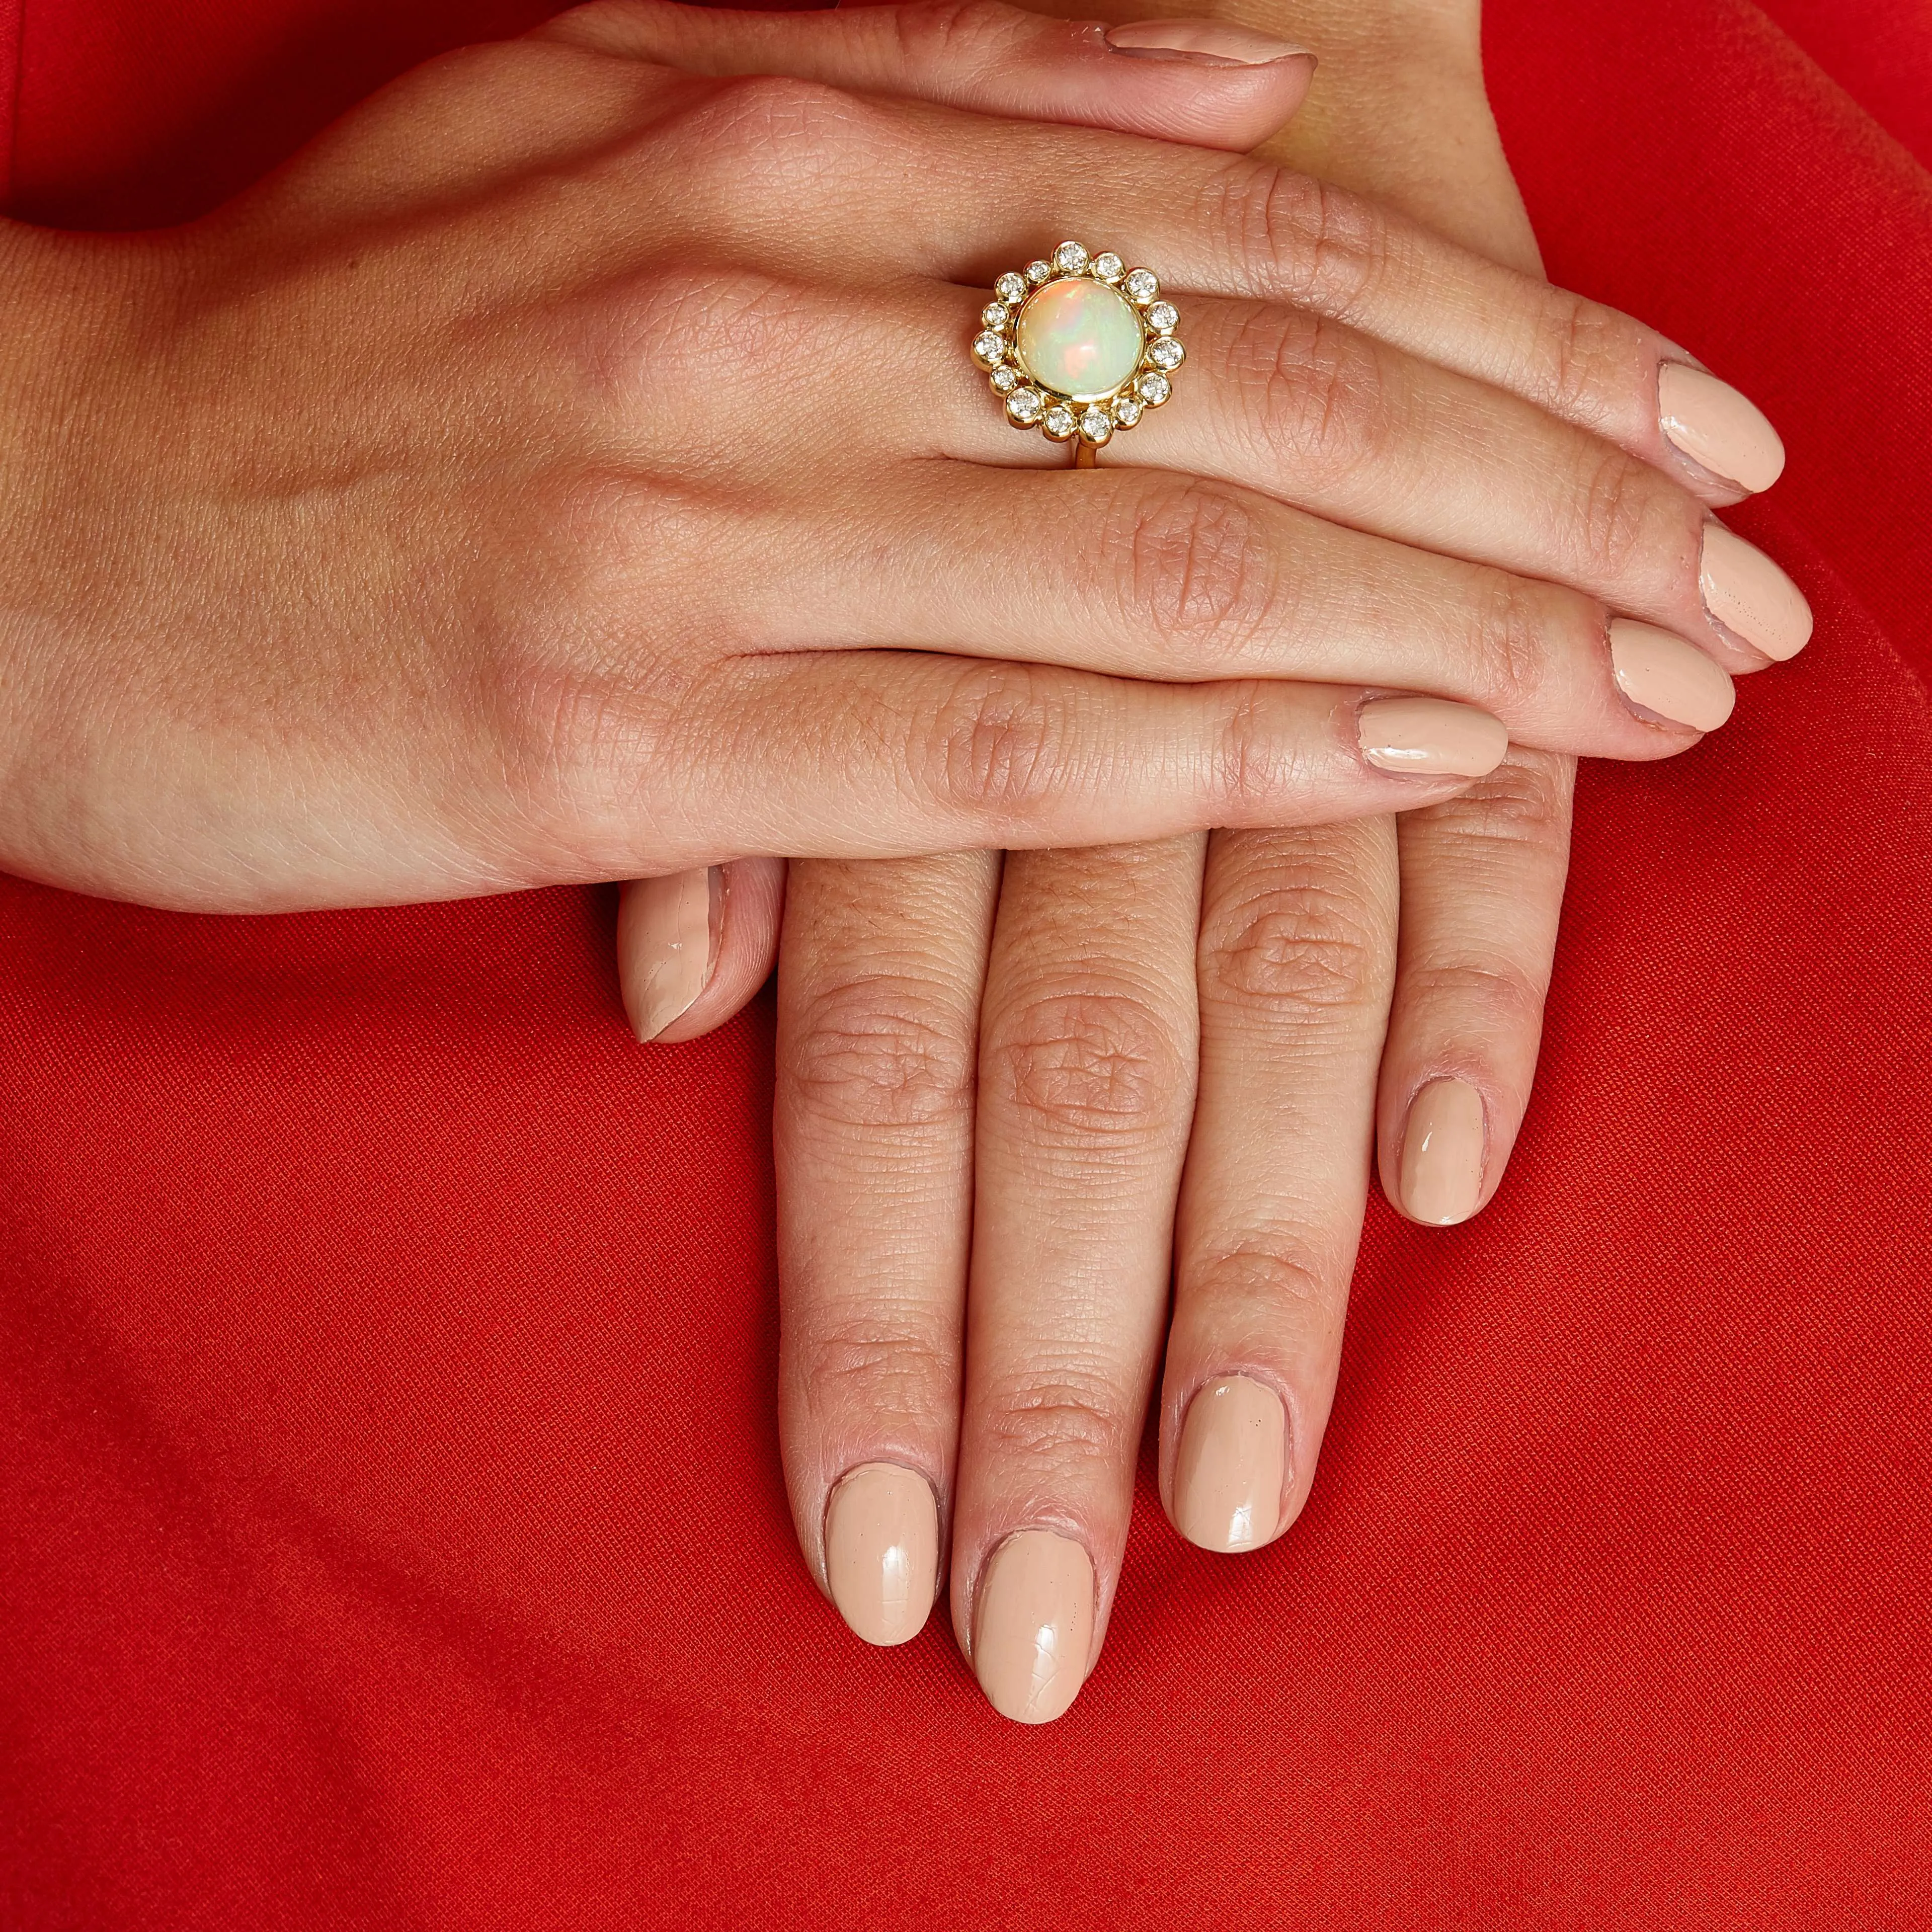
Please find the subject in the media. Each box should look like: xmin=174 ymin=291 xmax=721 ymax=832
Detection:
xmin=773 ymin=852 xmax=999 ymax=1644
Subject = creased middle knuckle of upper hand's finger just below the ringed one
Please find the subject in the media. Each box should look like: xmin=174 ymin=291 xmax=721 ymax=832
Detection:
xmin=1109 ymin=483 xmax=1277 ymax=665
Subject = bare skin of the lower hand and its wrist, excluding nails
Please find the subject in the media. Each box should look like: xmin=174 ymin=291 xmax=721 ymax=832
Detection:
xmin=614 ymin=6 xmax=1793 ymax=1723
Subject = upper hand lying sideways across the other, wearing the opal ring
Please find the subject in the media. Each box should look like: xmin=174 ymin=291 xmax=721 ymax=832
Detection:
xmin=0 ymin=6 xmax=1793 ymax=910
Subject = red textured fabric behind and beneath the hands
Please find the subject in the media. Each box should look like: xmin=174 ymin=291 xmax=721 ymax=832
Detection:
xmin=0 ymin=0 xmax=1932 ymax=1932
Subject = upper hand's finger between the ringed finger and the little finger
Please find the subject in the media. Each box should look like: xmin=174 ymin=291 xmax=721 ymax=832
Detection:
xmin=780 ymin=464 xmax=1733 ymax=759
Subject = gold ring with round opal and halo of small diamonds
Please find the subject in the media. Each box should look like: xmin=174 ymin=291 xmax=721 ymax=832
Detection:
xmin=972 ymin=242 xmax=1186 ymax=467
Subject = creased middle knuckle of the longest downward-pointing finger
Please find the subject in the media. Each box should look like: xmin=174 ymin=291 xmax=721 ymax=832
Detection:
xmin=987 ymin=991 xmax=1192 ymax=1138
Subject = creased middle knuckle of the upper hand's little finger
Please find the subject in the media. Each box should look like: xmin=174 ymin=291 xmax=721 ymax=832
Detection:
xmin=914 ymin=665 xmax=1072 ymax=819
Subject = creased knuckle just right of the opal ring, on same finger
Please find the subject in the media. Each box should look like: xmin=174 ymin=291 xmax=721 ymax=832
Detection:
xmin=1227 ymin=307 xmax=1397 ymax=485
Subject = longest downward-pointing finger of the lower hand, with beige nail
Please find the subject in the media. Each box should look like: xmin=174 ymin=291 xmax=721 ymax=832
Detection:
xmin=952 ymin=839 xmax=1201 ymax=1723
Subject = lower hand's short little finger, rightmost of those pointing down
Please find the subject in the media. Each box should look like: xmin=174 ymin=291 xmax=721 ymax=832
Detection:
xmin=1380 ymin=752 xmax=1575 ymax=1227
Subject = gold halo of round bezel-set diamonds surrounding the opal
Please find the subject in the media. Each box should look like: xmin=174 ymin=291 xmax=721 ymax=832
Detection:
xmin=972 ymin=242 xmax=1186 ymax=460
